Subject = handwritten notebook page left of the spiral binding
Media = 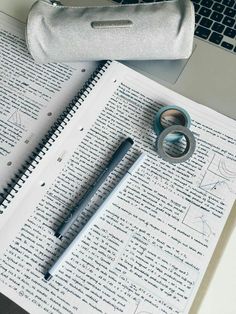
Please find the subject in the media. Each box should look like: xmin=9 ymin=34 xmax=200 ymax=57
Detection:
xmin=0 ymin=12 xmax=97 ymax=192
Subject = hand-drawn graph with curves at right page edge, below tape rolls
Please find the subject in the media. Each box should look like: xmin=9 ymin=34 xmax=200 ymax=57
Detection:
xmin=200 ymin=155 xmax=236 ymax=197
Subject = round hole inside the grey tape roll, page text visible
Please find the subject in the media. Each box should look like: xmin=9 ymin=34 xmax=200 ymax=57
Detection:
xmin=163 ymin=132 xmax=190 ymax=158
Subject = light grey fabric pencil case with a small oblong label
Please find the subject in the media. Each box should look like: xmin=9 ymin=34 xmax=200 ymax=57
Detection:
xmin=26 ymin=0 xmax=194 ymax=63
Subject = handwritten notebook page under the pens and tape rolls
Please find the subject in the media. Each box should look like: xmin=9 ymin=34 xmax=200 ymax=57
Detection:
xmin=0 ymin=62 xmax=236 ymax=314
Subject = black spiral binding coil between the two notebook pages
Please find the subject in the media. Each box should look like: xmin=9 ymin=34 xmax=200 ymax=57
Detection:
xmin=0 ymin=61 xmax=111 ymax=214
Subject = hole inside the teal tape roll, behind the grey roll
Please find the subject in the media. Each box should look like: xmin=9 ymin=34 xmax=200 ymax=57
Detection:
xmin=160 ymin=109 xmax=187 ymax=129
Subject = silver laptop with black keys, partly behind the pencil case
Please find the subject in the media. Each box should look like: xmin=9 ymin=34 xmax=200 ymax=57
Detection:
xmin=79 ymin=0 xmax=236 ymax=119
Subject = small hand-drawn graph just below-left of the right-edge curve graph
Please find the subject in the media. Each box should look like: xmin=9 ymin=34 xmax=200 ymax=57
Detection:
xmin=183 ymin=205 xmax=215 ymax=238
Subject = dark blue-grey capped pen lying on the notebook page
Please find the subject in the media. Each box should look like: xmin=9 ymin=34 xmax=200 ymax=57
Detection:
xmin=55 ymin=137 xmax=134 ymax=239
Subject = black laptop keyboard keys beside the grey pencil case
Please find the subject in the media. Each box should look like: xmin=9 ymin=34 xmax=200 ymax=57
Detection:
xmin=114 ymin=0 xmax=236 ymax=54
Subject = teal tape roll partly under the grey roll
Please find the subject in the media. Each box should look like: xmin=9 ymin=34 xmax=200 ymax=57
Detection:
xmin=153 ymin=105 xmax=191 ymax=142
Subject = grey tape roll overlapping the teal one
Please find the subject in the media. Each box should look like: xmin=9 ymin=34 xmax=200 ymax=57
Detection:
xmin=156 ymin=125 xmax=196 ymax=163
